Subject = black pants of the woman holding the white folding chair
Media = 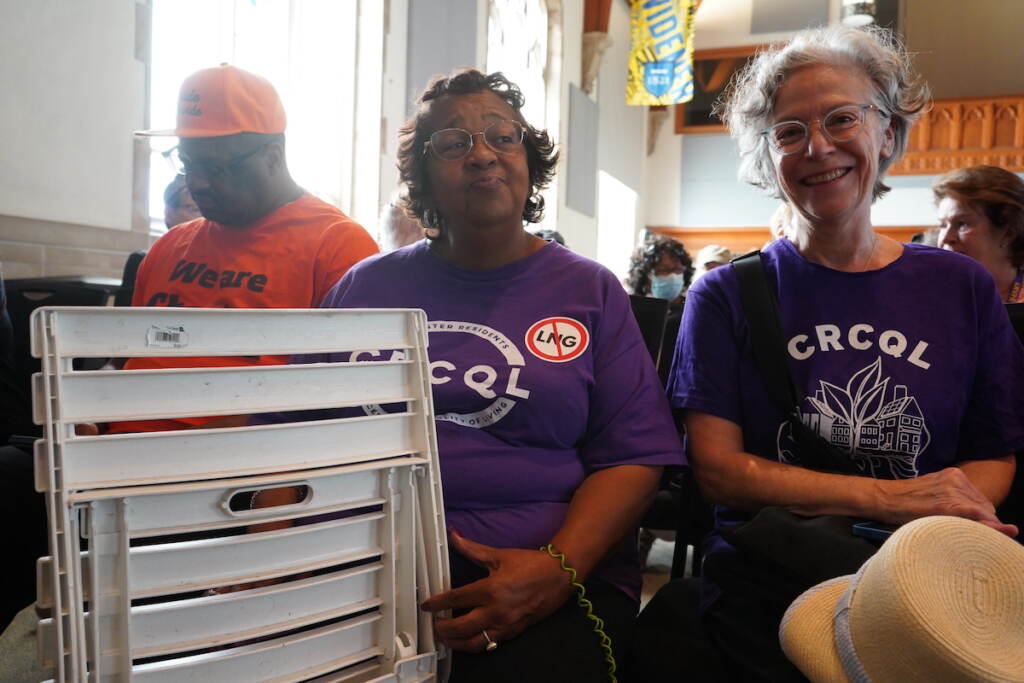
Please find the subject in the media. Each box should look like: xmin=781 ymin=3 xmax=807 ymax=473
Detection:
xmin=450 ymin=585 xmax=637 ymax=683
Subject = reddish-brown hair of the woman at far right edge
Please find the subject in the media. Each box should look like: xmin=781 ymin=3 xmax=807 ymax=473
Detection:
xmin=932 ymin=166 xmax=1024 ymax=268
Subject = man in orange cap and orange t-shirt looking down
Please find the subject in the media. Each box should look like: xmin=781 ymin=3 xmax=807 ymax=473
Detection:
xmin=111 ymin=65 xmax=378 ymax=432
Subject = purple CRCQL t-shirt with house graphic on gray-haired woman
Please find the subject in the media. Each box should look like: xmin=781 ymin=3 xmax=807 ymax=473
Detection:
xmin=669 ymin=240 xmax=1024 ymax=544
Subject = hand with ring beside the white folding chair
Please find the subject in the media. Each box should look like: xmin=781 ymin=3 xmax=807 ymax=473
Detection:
xmin=420 ymin=530 xmax=572 ymax=652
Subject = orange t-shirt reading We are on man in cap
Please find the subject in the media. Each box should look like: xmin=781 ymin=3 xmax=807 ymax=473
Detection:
xmin=110 ymin=195 xmax=378 ymax=433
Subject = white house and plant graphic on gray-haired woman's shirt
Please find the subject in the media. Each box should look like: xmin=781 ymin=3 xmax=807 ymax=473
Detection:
xmin=778 ymin=356 xmax=931 ymax=479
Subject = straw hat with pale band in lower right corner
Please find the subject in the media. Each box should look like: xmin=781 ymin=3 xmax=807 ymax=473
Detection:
xmin=779 ymin=517 xmax=1024 ymax=683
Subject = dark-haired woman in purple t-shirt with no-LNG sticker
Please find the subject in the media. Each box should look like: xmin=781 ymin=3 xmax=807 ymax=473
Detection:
xmin=322 ymin=70 xmax=682 ymax=681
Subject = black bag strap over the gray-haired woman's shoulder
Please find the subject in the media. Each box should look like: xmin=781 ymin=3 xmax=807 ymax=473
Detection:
xmin=732 ymin=251 xmax=804 ymax=415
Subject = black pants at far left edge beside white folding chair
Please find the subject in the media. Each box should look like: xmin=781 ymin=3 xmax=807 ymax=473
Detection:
xmin=0 ymin=445 xmax=48 ymax=631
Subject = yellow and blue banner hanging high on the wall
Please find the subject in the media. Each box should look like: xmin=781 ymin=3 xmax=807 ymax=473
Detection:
xmin=626 ymin=0 xmax=697 ymax=104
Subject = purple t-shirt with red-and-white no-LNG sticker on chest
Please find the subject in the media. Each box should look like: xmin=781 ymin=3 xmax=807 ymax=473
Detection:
xmin=284 ymin=241 xmax=682 ymax=598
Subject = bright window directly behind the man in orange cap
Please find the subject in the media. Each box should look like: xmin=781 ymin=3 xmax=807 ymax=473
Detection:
xmin=150 ymin=0 xmax=384 ymax=231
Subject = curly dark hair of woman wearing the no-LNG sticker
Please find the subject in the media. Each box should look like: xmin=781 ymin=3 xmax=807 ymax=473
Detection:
xmin=398 ymin=69 xmax=558 ymax=227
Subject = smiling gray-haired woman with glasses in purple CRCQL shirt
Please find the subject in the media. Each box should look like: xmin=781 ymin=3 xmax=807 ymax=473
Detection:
xmin=643 ymin=27 xmax=1024 ymax=681
